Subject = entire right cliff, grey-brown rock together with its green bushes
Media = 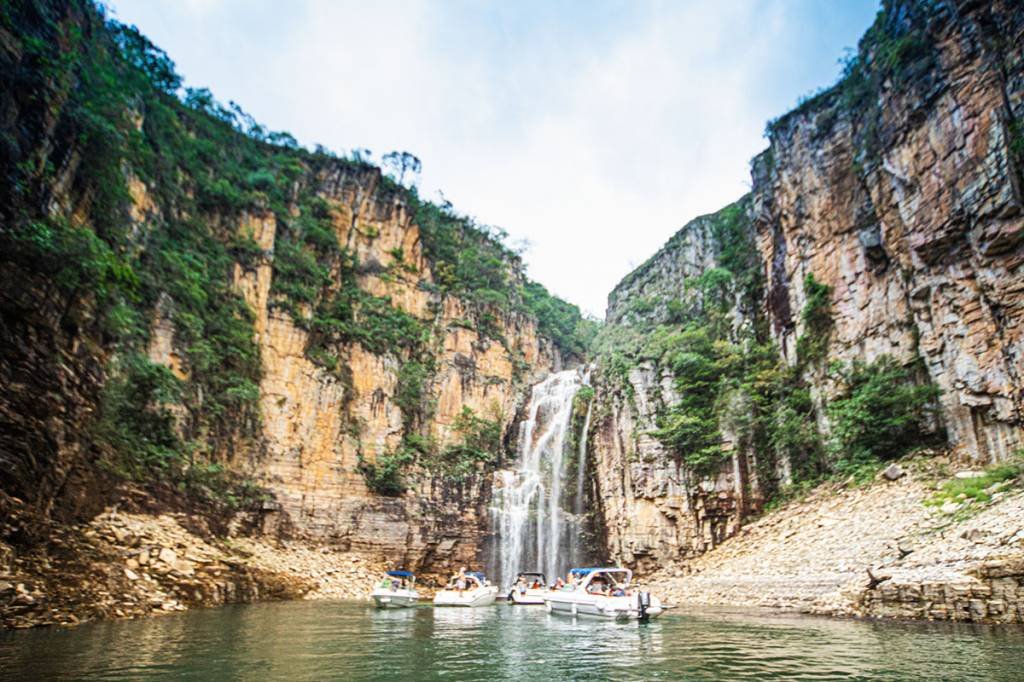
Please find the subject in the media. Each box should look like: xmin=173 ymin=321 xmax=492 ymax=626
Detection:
xmin=591 ymin=1 xmax=1024 ymax=620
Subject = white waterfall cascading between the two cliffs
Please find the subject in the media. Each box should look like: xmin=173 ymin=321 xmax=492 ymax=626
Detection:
xmin=490 ymin=370 xmax=589 ymax=585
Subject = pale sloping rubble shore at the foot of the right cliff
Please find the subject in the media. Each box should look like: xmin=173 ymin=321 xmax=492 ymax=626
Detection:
xmin=646 ymin=458 xmax=1024 ymax=623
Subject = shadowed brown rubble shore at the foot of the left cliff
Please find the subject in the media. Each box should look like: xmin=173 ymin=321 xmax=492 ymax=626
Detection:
xmin=0 ymin=493 xmax=384 ymax=628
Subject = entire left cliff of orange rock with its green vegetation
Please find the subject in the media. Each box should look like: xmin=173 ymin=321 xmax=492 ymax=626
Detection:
xmin=0 ymin=0 xmax=587 ymax=602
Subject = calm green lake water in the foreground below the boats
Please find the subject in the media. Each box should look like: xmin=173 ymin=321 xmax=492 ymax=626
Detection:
xmin=0 ymin=601 xmax=1024 ymax=682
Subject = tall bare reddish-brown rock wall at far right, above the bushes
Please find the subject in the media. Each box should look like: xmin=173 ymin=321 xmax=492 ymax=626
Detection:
xmin=753 ymin=2 xmax=1024 ymax=462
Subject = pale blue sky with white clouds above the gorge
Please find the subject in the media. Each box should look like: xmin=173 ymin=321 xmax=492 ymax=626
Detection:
xmin=105 ymin=0 xmax=878 ymax=317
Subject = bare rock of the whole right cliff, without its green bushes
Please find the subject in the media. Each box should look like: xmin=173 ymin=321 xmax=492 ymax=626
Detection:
xmin=592 ymin=1 xmax=1024 ymax=568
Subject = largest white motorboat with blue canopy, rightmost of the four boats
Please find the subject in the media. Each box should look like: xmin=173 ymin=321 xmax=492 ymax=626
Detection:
xmin=544 ymin=567 xmax=665 ymax=621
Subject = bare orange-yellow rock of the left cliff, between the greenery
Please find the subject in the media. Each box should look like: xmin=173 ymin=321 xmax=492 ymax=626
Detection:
xmin=224 ymin=166 xmax=562 ymax=573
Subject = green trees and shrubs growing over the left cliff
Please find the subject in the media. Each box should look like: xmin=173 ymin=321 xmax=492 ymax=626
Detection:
xmin=0 ymin=0 xmax=595 ymax=503
